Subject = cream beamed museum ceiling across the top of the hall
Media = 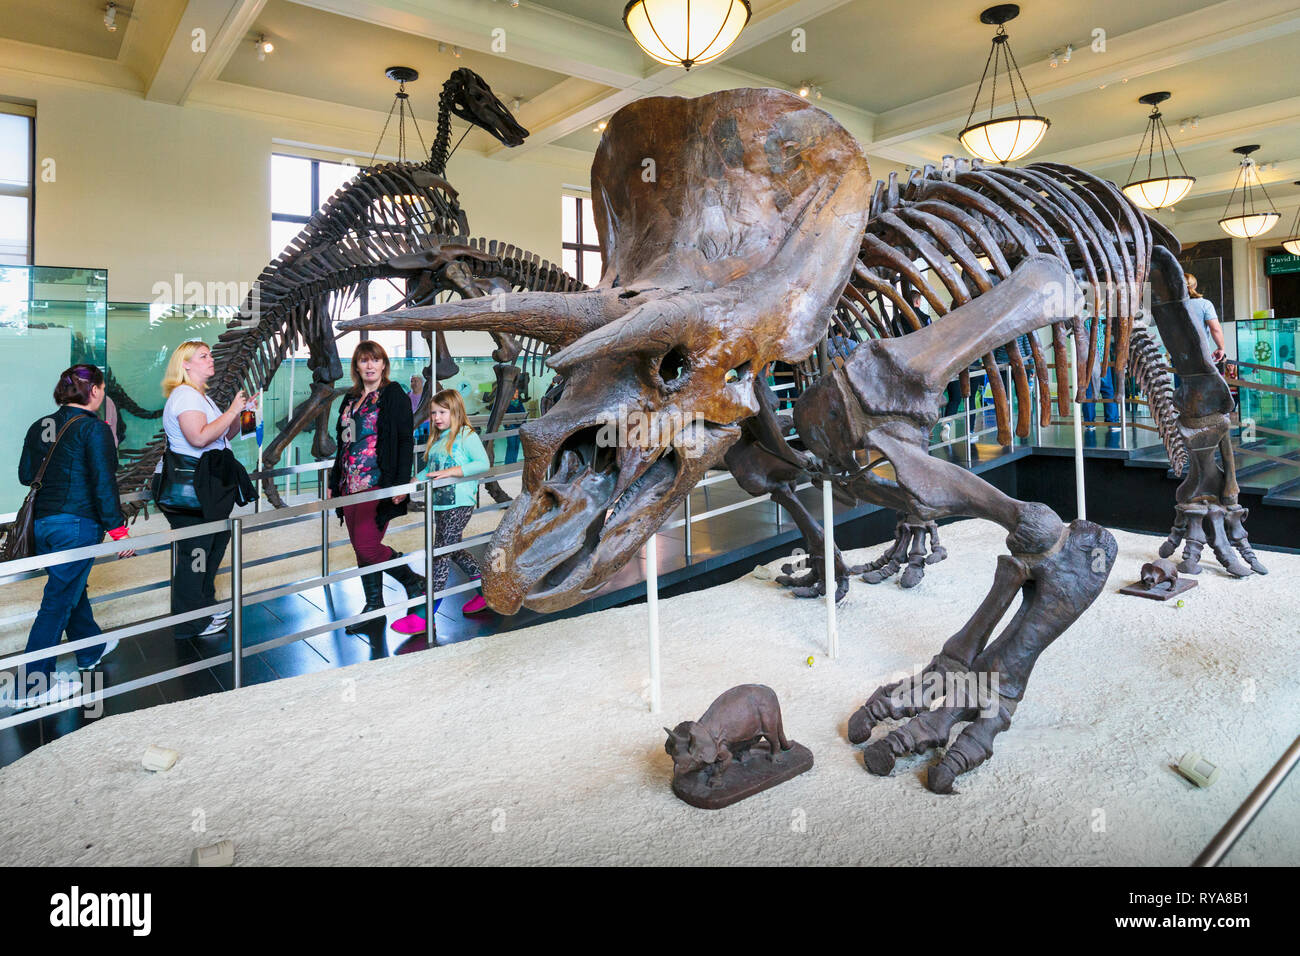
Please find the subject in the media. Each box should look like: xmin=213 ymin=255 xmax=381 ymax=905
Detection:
xmin=0 ymin=0 xmax=1300 ymax=227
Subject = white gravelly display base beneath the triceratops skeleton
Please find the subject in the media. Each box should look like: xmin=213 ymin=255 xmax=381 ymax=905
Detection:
xmin=0 ymin=522 xmax=1300 ymax=865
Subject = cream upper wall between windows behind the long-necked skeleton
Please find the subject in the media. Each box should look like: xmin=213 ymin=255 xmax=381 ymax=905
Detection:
xmin=0 ymin=70 xmax=589 ymax=352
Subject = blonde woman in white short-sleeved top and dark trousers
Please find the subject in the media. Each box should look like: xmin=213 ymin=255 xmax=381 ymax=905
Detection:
xmin=157 ymin=341 xmax=248 ymax=640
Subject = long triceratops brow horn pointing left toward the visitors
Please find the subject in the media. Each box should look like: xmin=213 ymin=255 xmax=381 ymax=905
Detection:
xmin=338 ymin=289 xmax=634 ymax=346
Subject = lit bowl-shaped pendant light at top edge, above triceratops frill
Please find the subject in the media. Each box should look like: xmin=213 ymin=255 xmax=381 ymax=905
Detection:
xmin=623 ymin=0 xmax=750 ymax=70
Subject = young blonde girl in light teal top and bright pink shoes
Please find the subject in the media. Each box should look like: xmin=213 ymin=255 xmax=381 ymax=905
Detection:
xmin=393 ymin=389 xmax=488 ymax=633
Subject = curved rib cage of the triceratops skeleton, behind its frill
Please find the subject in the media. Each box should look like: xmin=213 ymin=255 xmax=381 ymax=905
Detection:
xmin=800 ymin=159 xmax=1186 ymax=462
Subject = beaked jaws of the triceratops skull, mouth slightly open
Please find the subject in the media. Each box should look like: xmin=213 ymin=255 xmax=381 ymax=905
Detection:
xmin=484 ymin=421 xmax=740 ymax=614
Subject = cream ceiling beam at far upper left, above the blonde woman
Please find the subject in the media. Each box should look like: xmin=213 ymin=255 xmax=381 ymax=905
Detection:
xmin=144 ymin=0 xmax=267 ymax=105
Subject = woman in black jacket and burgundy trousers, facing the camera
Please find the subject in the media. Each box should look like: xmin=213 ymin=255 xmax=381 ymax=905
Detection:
xmin=329 ymin=339 xmax=424 ymax=633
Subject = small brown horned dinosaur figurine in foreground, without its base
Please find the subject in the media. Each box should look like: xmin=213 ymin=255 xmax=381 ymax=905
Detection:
xmin=663 ymin=684 xmax=790 ymax=787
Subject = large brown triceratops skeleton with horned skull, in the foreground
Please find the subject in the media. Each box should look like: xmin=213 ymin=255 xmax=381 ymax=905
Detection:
xmin=343 ymin=90 xmax=1258 ymax=792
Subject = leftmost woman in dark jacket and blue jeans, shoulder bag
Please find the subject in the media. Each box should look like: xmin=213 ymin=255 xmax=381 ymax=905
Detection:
xmin=17 ymin=364 xmax=134 ymax=706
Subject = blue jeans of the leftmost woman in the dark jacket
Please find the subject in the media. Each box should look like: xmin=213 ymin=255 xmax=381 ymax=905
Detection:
xmin=21 ymin=514 xmax=104 ymax=693
